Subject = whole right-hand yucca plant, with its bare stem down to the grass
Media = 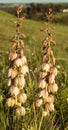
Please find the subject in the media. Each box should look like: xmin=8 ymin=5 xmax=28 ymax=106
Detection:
xmin=35 ymin=8 xmax=58 ymax=130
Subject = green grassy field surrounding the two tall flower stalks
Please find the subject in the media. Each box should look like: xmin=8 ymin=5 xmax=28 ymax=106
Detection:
xmin=0 ymin=11 xmax=68 ymax=130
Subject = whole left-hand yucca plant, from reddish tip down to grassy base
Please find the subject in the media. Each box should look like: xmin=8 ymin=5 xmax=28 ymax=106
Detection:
xmin=6 ymin=6 xmax=29 ymax=130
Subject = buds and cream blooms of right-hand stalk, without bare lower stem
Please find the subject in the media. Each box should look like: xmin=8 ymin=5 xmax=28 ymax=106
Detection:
xmin=35 ymin=8 xmax=58 ymax=116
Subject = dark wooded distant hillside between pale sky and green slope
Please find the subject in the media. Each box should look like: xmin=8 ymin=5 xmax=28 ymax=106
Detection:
xmin=0 ymin=3 xmax=68 ymax=25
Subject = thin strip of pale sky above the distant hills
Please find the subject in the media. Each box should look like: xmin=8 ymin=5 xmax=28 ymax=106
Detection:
xmin=0 ymin=0 xmax=68 ymax=3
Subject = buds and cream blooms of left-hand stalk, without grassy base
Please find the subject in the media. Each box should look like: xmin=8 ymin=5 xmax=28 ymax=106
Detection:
xmin=6 ymin=7 xmax=29 ymax=116
